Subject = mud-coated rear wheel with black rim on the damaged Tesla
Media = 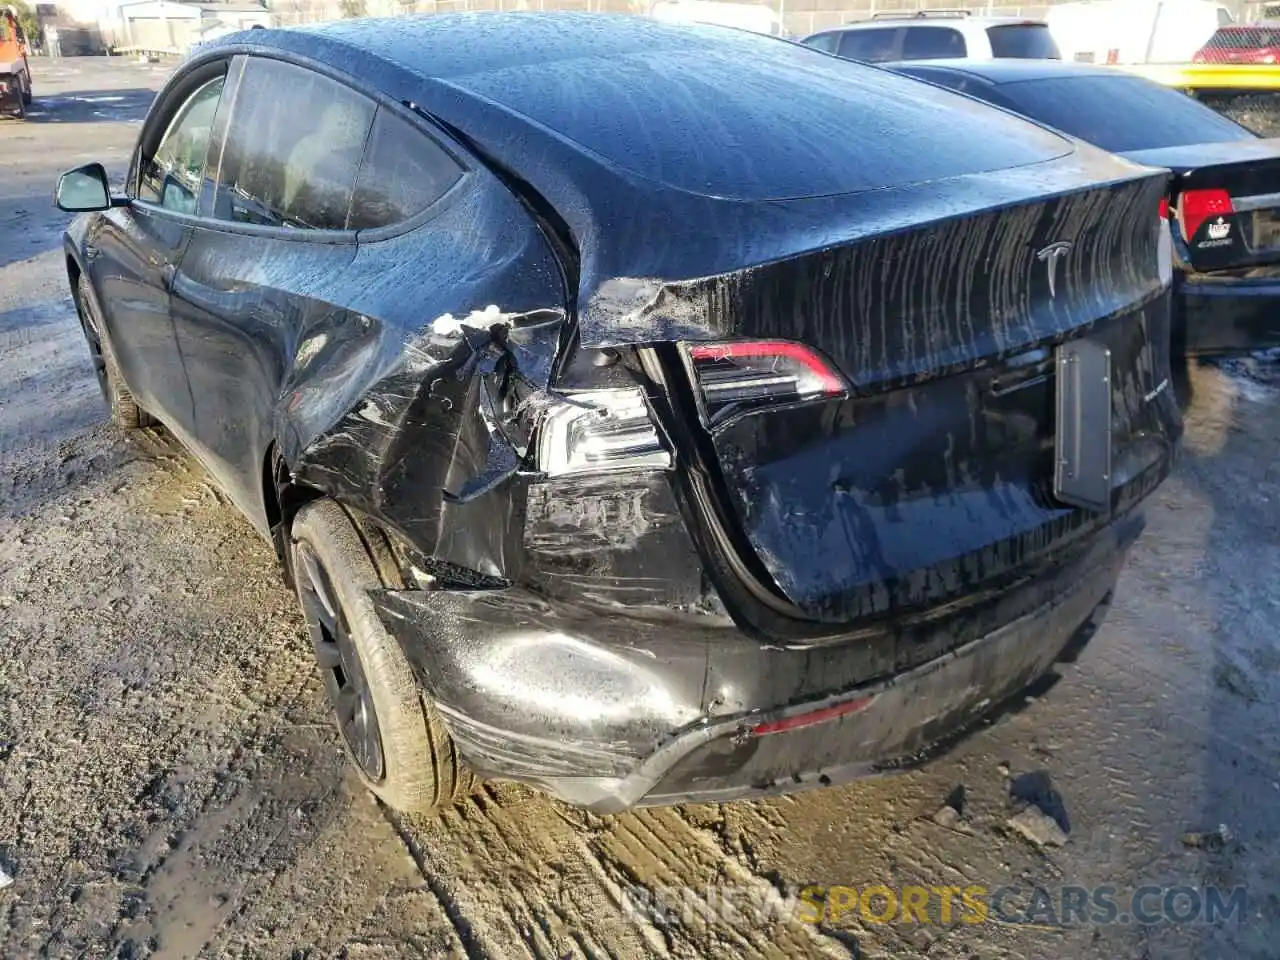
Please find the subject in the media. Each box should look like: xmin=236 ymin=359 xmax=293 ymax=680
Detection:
xmin=289 ymin=499 xmax=476 ymax=813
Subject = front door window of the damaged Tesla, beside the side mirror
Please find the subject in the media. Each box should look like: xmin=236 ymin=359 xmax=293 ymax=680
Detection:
xmin=138 ymin=77 xmax=224 ymax=214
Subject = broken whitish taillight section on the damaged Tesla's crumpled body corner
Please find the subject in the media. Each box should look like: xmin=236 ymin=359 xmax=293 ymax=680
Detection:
xmin=538 ymin=387 xmax=671 ymax=476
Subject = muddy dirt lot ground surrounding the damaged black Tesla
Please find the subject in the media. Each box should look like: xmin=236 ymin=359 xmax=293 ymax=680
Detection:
xmin=0 ymin=60 xmax=1280 ymax=960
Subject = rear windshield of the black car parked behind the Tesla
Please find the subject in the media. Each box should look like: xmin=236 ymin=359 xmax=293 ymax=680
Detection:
xmin=1000 ymin=77 xmax=1253 ymax=152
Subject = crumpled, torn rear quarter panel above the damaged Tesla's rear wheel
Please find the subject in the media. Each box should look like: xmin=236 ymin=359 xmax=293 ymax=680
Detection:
xmin=279 ymin=174 xmax=566 ymax=579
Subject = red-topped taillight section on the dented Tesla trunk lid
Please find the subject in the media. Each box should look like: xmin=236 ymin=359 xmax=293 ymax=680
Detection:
xmin=685 ymin=340 xmax=849 ymax=424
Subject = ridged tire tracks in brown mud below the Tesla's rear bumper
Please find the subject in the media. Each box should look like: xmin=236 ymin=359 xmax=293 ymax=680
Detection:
xmin=384 ymin=785 xmax=854 ymax=960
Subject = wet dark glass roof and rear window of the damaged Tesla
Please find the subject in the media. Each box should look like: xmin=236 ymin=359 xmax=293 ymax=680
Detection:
xmin=211 ymin=13 xmax=1071 ymax=201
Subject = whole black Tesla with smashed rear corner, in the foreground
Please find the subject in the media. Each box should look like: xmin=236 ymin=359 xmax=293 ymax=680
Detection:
xmin=59 ymin=14 xmax=1180 ymax=810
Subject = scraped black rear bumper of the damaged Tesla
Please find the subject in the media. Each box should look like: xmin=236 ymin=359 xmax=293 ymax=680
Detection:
xmin=375 ymin=513 xmax=1142 ymax=813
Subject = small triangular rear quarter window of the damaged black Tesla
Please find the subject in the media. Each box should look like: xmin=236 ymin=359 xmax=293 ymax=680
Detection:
xmin=347 ymin=109 xmax=462 ymax=230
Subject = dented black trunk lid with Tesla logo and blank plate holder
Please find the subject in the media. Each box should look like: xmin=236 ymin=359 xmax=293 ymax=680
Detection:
xmin=685 ymin=175 xmax=1180 ymax=627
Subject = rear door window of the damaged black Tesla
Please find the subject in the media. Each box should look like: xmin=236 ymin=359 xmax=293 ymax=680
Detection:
xmin=214 ymin=58 xmax=376 ymax=230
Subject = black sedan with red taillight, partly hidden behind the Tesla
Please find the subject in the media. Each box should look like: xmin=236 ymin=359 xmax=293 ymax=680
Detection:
xmin=886 ymin=60 xmax=1280 ymax=356
